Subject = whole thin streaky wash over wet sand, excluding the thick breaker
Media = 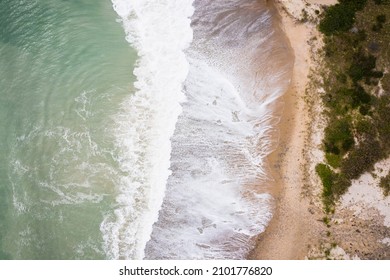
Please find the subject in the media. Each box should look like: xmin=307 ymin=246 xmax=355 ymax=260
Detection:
xmin=146 ymin=0 xmax=292 ymax=259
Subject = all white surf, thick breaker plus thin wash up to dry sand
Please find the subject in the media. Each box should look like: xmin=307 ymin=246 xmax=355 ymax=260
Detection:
xmin=101 ymin=0 xmax=292 ymax=259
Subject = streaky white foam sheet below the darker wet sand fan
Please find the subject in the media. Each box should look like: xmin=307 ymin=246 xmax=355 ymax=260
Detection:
xmin=146 ymin=59 xmax=271 ymax=259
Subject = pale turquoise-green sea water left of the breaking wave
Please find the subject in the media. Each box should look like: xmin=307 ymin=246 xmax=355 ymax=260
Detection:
xmin=0 ymin=0 xmax=136 ymax=259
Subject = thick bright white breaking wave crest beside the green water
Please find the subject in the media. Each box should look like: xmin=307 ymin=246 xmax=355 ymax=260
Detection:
xmin=101 ymin=0 xmax=193 ymax=259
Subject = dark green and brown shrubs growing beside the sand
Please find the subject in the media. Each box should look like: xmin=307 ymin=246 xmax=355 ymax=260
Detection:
xmin=316 ymin=0 xmax=390 ymax=213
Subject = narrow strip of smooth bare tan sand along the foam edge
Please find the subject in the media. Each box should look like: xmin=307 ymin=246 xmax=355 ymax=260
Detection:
xmin=248 ymin=0 xmax=336 ymax=260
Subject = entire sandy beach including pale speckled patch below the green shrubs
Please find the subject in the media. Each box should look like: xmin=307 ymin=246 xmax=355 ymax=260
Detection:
xmin=248 ymin=0 xmax=390 ymax=260
